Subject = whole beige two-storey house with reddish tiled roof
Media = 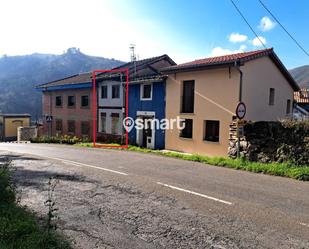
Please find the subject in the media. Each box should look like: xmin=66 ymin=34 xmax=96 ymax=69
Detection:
xmin=162 ymin=49 xmax=299 ymax=156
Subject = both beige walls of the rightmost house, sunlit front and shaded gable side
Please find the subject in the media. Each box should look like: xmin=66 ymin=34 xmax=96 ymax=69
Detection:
xmin=165 ymin=57 xmax=293 ymax=156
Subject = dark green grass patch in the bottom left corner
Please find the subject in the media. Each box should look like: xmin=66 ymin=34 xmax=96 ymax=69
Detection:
xmin=0 ymin=162 xmax=71 ymax=249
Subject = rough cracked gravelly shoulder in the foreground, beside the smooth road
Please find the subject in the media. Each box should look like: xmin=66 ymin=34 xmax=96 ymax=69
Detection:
xmin=0 ymin=152 xmax=309 ymax=249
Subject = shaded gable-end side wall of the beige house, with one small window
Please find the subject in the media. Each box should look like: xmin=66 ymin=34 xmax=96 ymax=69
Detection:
xmin=242 ymin=57 xmax=294 ymax=121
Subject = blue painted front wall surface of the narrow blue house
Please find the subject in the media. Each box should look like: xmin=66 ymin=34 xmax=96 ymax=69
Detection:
xmin=129 ymin=82 xmax=165 ymax=149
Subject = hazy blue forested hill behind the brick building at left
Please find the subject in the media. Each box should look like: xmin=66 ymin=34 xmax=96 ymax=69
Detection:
xmin=0 ymin=48 xmax=124 ymax=119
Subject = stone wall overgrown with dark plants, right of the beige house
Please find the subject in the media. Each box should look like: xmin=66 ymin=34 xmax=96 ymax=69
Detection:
xmin=228 ymin=121 xmax=309 ymax=165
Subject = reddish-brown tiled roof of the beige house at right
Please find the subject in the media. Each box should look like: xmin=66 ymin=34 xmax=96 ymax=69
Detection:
xmin=161 ymin=48 xmax=299 ymax=91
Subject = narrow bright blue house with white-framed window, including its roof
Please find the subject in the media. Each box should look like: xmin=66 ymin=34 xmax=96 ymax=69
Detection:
xmin=112 ymin=55 xmax=176 ymax=149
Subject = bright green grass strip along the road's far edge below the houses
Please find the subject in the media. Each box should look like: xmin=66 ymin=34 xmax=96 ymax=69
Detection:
xmin=76 ymin=143 xmax=309 ymax=181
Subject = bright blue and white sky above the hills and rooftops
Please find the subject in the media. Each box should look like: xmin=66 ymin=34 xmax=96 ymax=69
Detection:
xmin=0 ymin=0 xmax=309 ymax=68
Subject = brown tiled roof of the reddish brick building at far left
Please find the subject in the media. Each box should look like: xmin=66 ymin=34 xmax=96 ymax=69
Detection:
xmin=37 ymin=72 xmax=92 ymax=88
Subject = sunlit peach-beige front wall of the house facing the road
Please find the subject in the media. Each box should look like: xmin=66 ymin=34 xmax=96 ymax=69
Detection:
xmin=165 ymin=68 xmax=239 ymax=156
